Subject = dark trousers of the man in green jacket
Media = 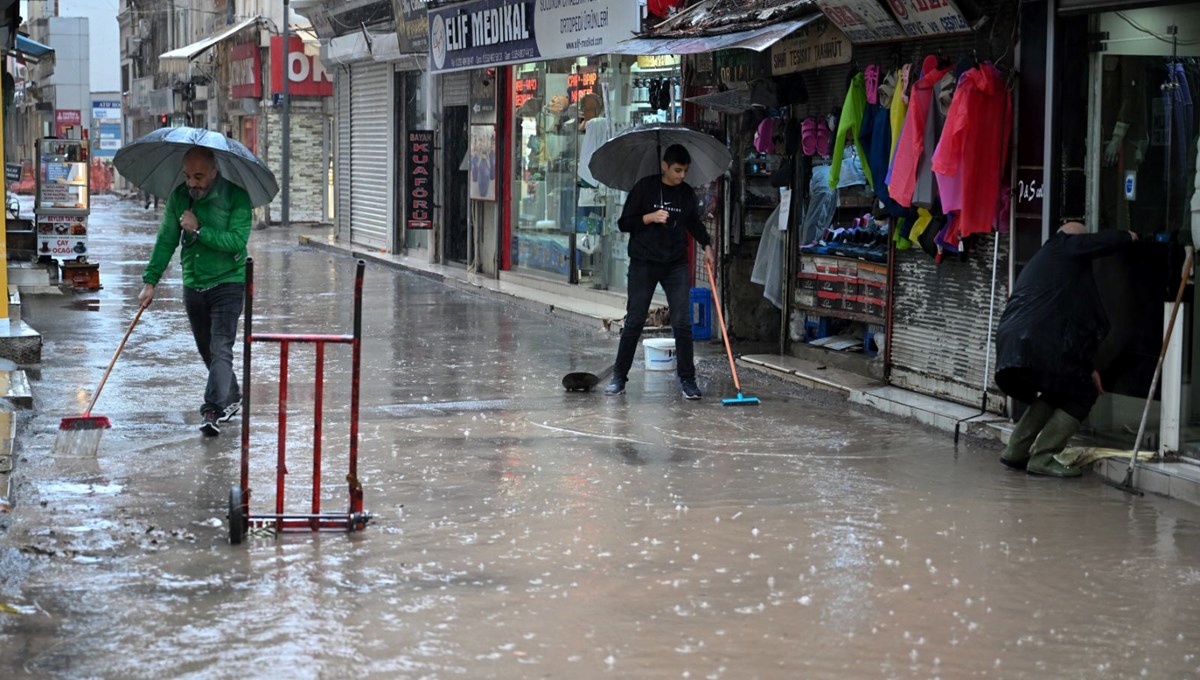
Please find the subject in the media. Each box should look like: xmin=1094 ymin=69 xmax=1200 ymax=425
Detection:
xmin=184 ymin=283 xmax=245 ymax=413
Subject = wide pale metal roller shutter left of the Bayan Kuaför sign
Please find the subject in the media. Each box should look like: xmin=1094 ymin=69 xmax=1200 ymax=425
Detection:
xmin=349 ymin=64 xmax=391 ymax=248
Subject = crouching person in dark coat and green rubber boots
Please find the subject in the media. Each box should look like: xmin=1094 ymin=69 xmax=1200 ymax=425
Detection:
xmin=996 ymin=222 xmax=1138 ymax=477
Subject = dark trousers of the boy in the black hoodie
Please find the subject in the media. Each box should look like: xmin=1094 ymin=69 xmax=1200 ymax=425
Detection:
xmin=612 ymin=260 xmax=696 ymax=380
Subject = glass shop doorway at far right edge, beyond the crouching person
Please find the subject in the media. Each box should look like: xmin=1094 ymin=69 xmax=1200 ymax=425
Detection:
xmin=1088 ymin=6 xmax=1200 ymax=457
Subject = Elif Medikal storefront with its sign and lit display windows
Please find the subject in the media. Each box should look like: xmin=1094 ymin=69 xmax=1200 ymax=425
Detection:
xmin=428 ymin=0 xmax=643 ymax=280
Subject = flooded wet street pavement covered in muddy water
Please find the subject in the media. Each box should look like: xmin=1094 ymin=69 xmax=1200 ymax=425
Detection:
xmin=0 ymin=198 xmax=1200 ymax=679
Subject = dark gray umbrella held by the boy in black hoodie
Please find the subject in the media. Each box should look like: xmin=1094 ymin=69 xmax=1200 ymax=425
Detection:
xmin=588 ymin=124 xmax=731 ymax=191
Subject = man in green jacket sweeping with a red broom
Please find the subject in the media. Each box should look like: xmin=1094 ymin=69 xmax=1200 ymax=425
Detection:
xmin=138 ymin=146 xmax=251 ymax=437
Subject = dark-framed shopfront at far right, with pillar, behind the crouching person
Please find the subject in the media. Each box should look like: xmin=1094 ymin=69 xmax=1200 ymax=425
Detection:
xmin=1032 ymin=0 xmax=1200 ymax=458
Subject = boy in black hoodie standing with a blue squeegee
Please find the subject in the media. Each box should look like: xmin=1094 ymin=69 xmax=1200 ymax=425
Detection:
xmin=605 ymin=144 xmax=713 ymax=399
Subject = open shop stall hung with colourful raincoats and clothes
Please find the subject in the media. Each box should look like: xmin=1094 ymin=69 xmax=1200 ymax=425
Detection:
xmin=667 ymin=2 xmax=1016 ymax=410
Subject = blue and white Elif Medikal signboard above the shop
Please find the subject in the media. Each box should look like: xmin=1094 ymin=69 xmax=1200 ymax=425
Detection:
xmin=428 ymin=0 xmax=640 ymax=72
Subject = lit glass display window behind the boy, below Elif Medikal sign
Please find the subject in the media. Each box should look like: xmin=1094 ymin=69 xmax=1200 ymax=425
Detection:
xmin=505 ymin=55 xmax=682 ymax=289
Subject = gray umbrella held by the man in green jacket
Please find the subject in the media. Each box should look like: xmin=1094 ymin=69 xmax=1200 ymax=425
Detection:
xmin=113 ymin=127 xmax=280 ymax=206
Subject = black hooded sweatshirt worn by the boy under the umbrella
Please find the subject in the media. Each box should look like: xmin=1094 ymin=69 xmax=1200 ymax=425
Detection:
xmin=617 ymin=175 xmax=709 ymax=263
